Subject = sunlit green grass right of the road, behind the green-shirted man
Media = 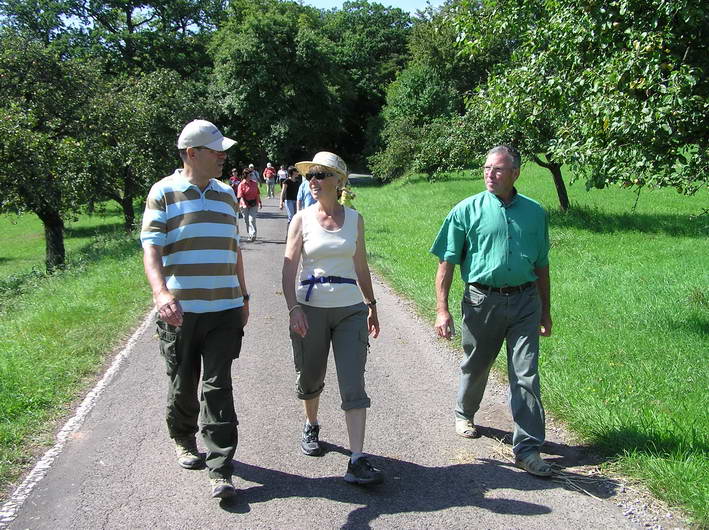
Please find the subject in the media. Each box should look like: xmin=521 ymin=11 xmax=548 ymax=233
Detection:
xmin=354 ymin=165 xmax=709 ymax=526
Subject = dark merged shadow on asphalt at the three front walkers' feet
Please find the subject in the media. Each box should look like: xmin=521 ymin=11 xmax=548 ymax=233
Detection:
xmin=221 ymin=443 xmax=612 ymax=528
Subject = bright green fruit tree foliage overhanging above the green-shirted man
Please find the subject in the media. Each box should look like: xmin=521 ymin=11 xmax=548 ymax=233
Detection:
xmin=456 ymin=0 xmax=709 ymax=198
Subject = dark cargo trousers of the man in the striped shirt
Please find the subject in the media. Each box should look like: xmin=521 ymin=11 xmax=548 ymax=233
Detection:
xmin=157 ymin=307 xmax=244 ymax=478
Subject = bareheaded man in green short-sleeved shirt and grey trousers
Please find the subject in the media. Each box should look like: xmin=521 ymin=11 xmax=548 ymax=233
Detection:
xmin=431 ymin=146 xmax=552 ymax=477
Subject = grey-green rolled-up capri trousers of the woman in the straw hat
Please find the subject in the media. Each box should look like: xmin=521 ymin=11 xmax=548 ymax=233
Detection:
xmin=290 ymin=303 xmax=371 ymax=410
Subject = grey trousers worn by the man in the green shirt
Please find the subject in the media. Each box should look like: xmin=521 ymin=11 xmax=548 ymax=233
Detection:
xmin=455 ymin=284 xmax=544 ymax=457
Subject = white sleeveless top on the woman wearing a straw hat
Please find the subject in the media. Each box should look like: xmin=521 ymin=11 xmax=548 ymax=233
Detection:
xmin=296 ymin=204 xmax=363 ymax=307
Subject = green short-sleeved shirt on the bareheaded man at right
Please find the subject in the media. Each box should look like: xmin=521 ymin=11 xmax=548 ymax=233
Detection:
xmin=431 ymin=191 xmax=549 ymax=287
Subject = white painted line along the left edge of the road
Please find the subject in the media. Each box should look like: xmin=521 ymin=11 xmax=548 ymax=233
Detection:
xmin=0 ymin=309 xmax=155 ymax=529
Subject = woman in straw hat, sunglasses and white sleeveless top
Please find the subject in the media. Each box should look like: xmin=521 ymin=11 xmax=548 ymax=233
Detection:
xmin=283 ymin=152 xmax=382 ymax=485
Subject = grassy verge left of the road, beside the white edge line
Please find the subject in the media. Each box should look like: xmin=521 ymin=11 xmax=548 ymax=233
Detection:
xmin=0 ymin=204 xmax=149 ymax=491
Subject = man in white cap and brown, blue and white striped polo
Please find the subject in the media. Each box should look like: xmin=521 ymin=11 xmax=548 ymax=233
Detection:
xmin=140 ymin=120 xmax=249 ymax=498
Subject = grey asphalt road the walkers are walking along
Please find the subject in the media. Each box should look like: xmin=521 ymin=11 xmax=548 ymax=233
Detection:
xmin=5 ymin=199 xmax=635 ymax=529
